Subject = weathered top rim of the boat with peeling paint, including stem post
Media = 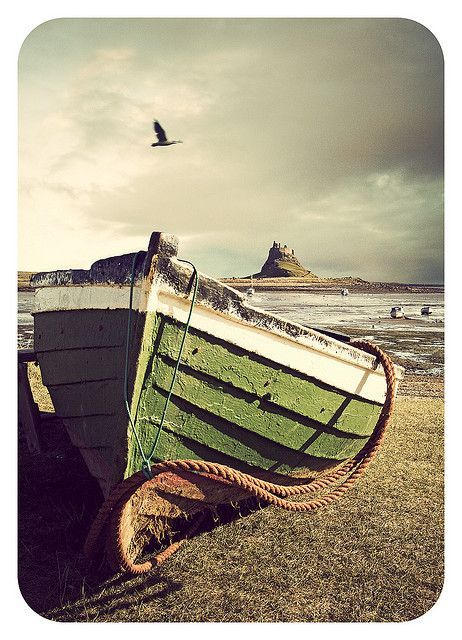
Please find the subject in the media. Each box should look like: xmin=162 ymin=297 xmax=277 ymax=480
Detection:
xmin=29 ymin=231 xmax=404 ymax=379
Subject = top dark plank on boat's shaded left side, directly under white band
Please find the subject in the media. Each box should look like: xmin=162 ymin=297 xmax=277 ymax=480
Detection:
xmin=34 ymin=309 xmax=144 ymax=352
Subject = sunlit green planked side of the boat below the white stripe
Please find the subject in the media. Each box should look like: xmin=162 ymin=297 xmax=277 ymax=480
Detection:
xmin=126 ymin=314 xmax=381 ymax=475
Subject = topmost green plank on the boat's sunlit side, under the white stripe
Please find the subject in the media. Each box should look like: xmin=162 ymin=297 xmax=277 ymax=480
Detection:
xmin=153 ymin=320 xmax=381 ymax=435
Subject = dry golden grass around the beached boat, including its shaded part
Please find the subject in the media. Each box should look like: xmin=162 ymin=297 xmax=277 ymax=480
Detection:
xmin=19 ymin=376 xmax=443 ymax=622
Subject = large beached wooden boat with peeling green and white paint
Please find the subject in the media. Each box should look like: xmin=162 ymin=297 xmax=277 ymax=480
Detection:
xmin=31 ymin=232 xmax=403 ymax=496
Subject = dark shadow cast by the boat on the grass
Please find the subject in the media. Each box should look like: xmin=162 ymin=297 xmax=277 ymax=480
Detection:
xmin=18 ymin=417 xmax=259 ymax=621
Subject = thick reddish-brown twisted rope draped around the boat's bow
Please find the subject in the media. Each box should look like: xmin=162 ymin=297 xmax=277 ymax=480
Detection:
xmin=84 ymin=341 xmax=396 ymax=574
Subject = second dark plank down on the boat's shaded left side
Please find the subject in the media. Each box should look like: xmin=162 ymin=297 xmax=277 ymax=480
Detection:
xmin=40 ymin=346 xmax=125 ymax=386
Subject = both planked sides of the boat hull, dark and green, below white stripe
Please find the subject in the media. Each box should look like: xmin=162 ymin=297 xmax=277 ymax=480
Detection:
xmin=35 ymin=310 xmax=381 ymax=485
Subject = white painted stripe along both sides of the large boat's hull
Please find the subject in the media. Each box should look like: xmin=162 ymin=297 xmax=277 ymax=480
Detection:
xmin=35 ymin=285 xmax=402 ymax=403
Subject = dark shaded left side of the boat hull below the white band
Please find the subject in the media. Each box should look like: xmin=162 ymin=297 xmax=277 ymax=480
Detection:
xmin=34 ymin=309 xmax=144 ymax=495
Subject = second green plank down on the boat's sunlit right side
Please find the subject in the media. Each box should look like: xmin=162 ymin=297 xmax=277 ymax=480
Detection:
xmin=140 ymin=359 xmax=373 ymax=460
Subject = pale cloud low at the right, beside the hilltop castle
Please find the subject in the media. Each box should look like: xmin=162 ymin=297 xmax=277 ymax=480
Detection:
xmin=292 ymin=171 xmax=443 ymax=282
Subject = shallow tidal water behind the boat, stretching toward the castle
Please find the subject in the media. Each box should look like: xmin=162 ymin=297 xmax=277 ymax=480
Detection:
xmin=18 ymin=290 xmax=444 ymax=375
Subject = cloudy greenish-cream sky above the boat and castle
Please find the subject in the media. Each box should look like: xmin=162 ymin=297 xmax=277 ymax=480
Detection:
xmin=18 ymin=18 xmax=444 ymax=283
